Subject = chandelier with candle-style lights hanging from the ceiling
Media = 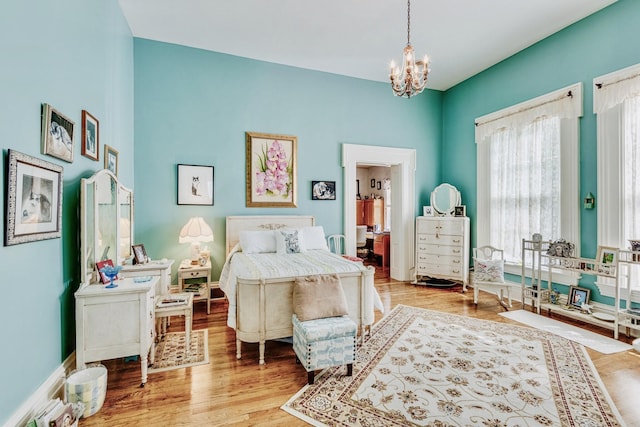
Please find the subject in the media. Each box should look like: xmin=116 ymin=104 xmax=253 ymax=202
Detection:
xmin=389 ymin=0 xmax=431 ymax=98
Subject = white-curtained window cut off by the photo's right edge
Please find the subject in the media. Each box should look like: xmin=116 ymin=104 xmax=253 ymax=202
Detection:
xmin=593 ymin=65 xmax=640 ymax=300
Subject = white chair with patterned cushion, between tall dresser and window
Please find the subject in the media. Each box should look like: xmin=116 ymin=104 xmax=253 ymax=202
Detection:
xmin=472 ymin=246 xmax=511 ymax=308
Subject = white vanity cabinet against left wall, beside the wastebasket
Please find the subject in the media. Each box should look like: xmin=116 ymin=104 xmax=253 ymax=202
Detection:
xmin=75 ymin=276 xmax=159 ymax=385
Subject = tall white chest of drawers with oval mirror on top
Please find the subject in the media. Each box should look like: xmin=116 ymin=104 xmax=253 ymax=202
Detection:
xmin=413 ymin=183 xmax=470 ymax=291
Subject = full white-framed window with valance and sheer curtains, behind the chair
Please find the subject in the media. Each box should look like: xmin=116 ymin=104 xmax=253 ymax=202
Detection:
xmin=476 ymin=84 xmax=582 ymax=283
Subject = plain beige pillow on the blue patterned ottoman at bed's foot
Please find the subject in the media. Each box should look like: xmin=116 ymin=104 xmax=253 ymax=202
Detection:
xmin=293 ymin=274 xmax=349 ymax=322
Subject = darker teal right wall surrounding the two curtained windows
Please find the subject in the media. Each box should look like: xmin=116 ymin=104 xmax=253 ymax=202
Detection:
xmin=442 ymin=0 xmax=640 ymax=302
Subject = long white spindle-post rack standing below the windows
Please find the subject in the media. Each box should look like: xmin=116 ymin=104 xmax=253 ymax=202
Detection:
xmin=522 ymin=239 xmax=620 ymax=339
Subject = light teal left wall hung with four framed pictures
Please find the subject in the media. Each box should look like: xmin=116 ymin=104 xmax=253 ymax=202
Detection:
xmin=0 ymin=0 xmax=133 ymax=424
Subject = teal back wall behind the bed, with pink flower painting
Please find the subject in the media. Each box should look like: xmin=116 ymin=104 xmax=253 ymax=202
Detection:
xmin=134 ymin=39 xmax=442 ymax=280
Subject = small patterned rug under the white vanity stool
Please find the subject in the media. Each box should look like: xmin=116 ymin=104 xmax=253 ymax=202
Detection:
xmin=149 ymin=329 xmax=209 ymax=374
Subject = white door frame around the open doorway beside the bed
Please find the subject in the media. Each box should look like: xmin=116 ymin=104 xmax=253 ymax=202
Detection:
xmin=342 ymin=144 xmax=416 ymax=281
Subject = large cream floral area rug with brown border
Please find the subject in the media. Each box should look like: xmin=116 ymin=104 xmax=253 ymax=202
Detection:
xmin=282 ymin=305 xmax=624 ymax=427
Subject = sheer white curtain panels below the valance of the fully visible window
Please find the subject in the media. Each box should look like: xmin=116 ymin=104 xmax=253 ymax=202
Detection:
xmin=489 ymin=117 xmax=561 ymax=262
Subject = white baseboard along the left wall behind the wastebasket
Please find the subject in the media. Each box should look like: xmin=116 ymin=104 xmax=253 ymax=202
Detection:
xmin=4 ymin=351 xmax=76 ymax=427
